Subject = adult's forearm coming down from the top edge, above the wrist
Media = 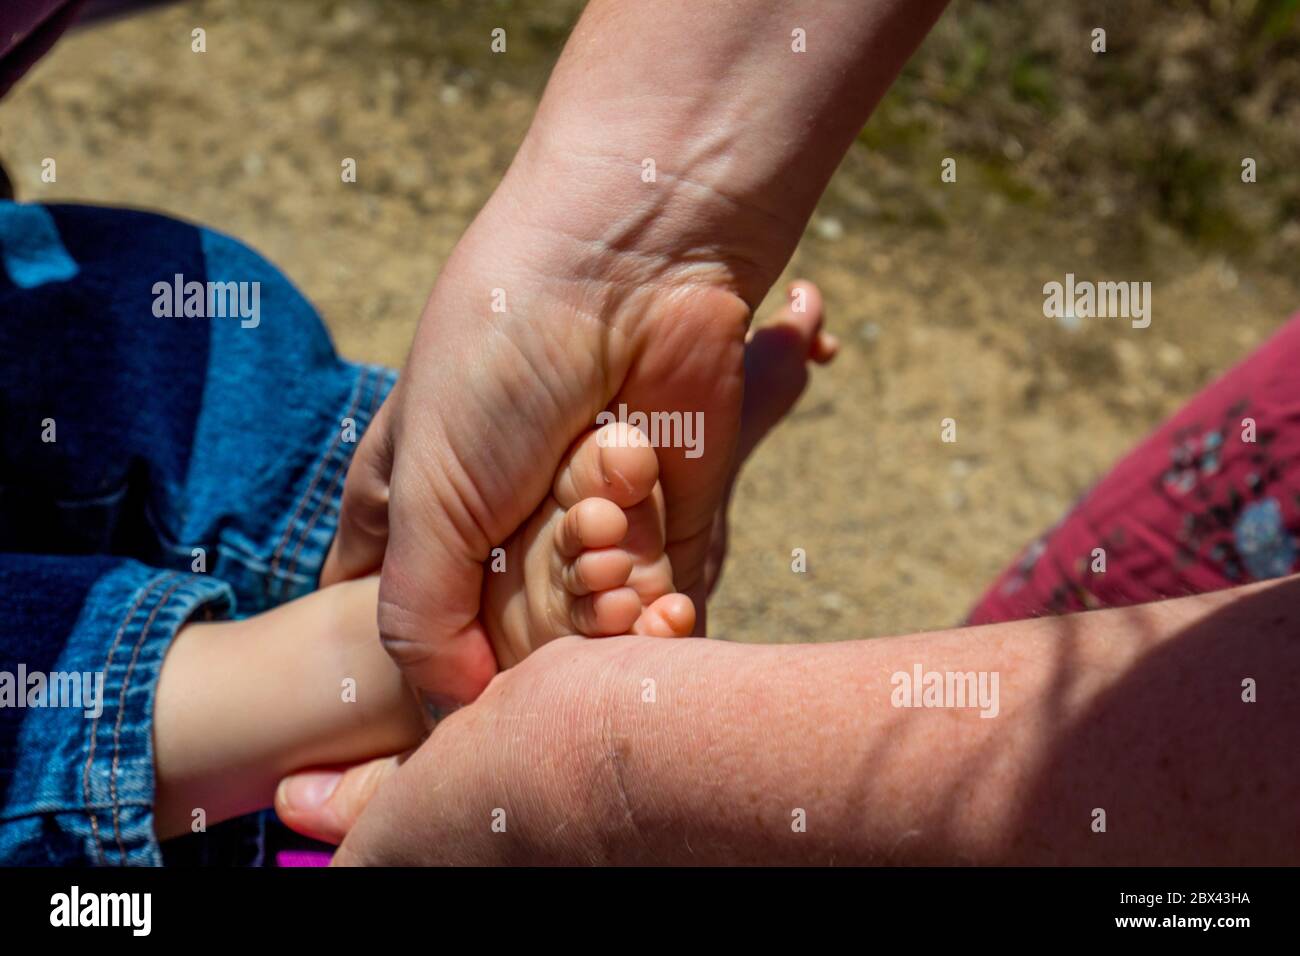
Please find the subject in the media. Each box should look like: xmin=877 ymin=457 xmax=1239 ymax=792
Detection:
xmin=493 ymin=0 xmax=945 ymax=306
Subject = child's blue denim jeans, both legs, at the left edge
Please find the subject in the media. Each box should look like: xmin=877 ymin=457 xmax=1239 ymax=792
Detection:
xmin=0 ymin=202 xmax=395 ymax=865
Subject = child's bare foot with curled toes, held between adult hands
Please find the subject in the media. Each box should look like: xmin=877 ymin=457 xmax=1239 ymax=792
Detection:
xmin=482 ymin=423 xmax=696 ymax=669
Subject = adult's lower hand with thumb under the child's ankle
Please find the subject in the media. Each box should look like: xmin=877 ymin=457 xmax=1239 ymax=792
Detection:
xmin=276 ymin=637 xmax=644 ymax=865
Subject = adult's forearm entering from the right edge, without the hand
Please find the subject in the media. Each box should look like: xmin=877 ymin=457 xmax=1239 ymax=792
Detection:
xmin=608 ymin=579 xmax=1300 ymax=864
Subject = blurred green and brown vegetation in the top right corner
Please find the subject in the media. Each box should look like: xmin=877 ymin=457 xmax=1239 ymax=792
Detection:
xmin=858 ymin=0 xmax=1300 ymax=261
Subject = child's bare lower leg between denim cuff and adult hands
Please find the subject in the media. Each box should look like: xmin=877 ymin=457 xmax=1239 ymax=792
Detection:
xmin=153 ymin=578 xmax=424 ymax=839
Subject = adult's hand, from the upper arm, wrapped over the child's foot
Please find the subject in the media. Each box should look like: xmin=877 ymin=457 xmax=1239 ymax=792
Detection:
xmin=322 ymin=196 xmax=750 ymax=709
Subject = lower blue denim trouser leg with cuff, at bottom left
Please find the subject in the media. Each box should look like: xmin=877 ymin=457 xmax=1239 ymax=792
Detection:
xmin=0 ymin=554 xmax=234 ymax=865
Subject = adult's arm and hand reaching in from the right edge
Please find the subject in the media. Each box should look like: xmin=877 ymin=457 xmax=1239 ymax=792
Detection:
xmin=280 ymin=578 xmax=1300 ymax=864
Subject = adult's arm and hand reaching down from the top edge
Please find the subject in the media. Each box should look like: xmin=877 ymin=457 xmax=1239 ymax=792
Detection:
xmin=324 ymin=0 xmax=944 ymax=705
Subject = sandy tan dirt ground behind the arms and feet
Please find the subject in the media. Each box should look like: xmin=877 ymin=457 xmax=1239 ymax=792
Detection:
xmin=0 ymin=0 xmax=1300 ymax=641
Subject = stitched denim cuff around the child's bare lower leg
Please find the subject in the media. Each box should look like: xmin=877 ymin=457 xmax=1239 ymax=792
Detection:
xmin=0 ymin=561 xmax=234 ymax=866
